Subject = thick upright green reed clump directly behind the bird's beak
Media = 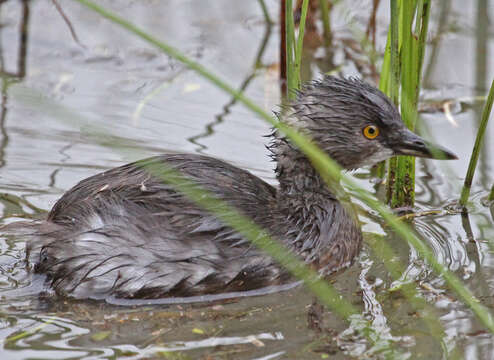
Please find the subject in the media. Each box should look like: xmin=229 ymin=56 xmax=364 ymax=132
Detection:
xmin=388 ymin=0 xmax=431 ymax=207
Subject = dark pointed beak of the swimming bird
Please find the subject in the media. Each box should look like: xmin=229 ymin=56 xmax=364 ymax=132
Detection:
xmin=392 ymin=129 xmax=458 ymax=160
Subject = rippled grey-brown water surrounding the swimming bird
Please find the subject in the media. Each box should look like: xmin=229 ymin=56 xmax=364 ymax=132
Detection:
xmin=0 ymin=0 xmax=494 ymax=359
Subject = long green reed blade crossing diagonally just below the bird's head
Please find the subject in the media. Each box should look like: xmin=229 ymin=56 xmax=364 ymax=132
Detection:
xmin=75 ymin=0 xmax=494 ymax=333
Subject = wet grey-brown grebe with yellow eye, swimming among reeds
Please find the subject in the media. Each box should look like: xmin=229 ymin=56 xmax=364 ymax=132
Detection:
xmin=22 ymin=76 xmax=456 ymax=299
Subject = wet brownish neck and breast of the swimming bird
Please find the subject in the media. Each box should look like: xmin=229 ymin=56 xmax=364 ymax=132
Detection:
xmin=269 ymin=137 xmax=362 ymax=275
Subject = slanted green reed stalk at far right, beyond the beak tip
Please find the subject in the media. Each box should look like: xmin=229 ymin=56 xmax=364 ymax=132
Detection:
xmin=460 ymin=80 xmax=494 ymax=207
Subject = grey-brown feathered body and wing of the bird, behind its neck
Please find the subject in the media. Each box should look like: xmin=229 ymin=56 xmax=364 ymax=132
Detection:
xmin=29 ymin=154 xmax=281 ymax=298
